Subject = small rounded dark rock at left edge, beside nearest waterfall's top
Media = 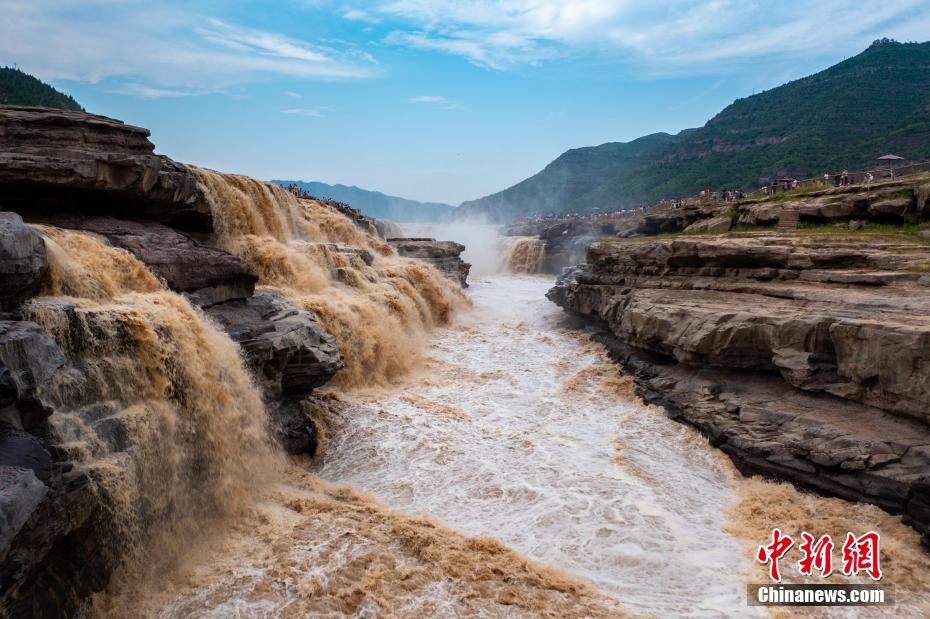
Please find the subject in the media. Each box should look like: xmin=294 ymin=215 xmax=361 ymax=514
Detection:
xmin=0 ymin=211 xmax=48 ymax=310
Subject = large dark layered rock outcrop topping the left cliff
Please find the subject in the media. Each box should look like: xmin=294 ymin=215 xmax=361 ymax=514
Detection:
xmin=0 ymin=105 xmax=212 ymax=231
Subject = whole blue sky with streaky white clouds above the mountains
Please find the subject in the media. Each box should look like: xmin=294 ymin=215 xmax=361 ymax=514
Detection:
xmin=0 ymin=0 xmax=930 ymax=204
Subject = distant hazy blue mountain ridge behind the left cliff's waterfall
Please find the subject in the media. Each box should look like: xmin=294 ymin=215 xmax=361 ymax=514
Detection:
xmin=271 ymin=181 xmax=455 ymax=222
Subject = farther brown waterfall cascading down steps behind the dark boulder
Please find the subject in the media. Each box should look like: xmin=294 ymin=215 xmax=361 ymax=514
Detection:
xmin=195 ymin=169 xmax=468 ymax=387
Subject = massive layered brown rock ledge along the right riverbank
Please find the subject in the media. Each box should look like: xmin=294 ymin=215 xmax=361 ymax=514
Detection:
xmin=548 ymin=234 xmax=930 ymax=539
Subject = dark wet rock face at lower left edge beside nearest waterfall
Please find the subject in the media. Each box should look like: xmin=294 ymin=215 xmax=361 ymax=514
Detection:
xmin=0 ymin=321 xmax=109 ymax=617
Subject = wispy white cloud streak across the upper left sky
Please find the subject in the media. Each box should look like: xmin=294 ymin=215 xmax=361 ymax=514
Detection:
xmin=0 ymin=0 xmax=376 ymax=96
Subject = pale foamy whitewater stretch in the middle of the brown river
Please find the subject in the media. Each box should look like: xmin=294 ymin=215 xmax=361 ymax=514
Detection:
xmin=319 ymin=275 xmax=748 ymax=615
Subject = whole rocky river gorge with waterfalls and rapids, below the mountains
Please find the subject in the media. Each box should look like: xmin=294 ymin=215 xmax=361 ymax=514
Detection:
xmin=0 ymin=106 xmax=930 ymax=617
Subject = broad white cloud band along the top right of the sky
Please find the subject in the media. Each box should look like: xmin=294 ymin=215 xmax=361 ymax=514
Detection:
xmin=378 ymin=0 xmax=930 ymax=70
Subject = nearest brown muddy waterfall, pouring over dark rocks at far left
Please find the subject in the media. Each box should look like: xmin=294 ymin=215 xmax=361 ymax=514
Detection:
xmin=24 ymin=226 xmax=279 ymax=588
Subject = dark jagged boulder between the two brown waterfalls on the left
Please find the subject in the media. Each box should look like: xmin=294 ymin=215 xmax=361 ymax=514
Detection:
xmin=206 ymin=293 xmax=345 ymax=400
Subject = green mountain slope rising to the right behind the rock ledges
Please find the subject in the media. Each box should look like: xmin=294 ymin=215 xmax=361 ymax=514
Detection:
xmin=456 ymin=39 xmax=930 ymax=222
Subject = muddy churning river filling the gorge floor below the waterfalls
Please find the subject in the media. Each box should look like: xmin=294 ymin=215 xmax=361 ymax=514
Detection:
xmin=100 ymin=236 xmax=930 ymax=617
